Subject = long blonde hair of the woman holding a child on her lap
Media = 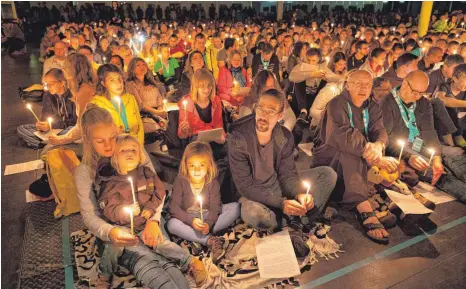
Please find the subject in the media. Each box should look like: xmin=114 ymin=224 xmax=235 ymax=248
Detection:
xmin=81 ymin=103 xmax=115 ymax=179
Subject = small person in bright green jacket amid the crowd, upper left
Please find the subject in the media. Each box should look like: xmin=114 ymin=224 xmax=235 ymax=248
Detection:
xmin=154 ymin=44 xmax=181 ymax=86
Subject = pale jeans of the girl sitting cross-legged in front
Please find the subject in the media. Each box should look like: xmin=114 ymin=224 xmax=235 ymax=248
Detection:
xmin=167 ymin=203 xmax=240 ymax=245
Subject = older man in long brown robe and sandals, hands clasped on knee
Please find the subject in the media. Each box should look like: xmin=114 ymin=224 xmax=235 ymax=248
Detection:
xmin=312 ymin=70 xmax=398 ymax=244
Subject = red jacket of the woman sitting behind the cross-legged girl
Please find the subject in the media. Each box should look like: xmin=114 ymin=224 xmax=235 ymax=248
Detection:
xmin=178 ymin=94 xmax=223 ymax=136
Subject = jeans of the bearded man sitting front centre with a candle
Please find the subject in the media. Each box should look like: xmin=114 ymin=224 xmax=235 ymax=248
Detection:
xmin=240 ymin=167 xmax=337 ymax=230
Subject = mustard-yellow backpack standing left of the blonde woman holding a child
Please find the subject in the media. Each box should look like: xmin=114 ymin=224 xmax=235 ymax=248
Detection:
xmin=46 ymin=148 xmax=79 ymax=218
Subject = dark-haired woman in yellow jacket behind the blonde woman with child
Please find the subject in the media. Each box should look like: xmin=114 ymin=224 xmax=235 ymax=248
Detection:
xmin=90 ymin=64 xmax=144 ymax=145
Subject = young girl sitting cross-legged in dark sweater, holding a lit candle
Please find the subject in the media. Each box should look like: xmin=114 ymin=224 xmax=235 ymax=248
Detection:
xmin=167 ymin=141 xmax=240 ymax=263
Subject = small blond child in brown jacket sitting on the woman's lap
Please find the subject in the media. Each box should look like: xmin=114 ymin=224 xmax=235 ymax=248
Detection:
xmin=98 ymin=134 xmax=207 ymax=289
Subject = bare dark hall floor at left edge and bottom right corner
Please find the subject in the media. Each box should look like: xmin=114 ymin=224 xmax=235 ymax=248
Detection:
xmin=1 ymin=50 xmax=466 ymax=289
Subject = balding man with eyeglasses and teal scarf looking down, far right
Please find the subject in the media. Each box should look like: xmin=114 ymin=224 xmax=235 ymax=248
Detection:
xmin=380 ymin=71 xmax=466 ymax=202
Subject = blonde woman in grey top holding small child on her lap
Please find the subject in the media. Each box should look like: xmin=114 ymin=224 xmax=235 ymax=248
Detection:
xmin=75 ymin=104 xmax=189 ymax=289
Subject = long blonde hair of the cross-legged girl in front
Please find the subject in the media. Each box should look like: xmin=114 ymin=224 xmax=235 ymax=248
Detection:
xmin=179 ymin=141 xmax=218 ymax=184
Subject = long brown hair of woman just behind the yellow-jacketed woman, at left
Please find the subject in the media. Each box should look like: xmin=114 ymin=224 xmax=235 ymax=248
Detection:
xmin=66 ymin=53 xmax=97 ymax=90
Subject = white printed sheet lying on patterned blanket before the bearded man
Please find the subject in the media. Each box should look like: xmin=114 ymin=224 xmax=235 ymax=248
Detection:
xmin=256 ymin=230 xmax=301 ymax=278
